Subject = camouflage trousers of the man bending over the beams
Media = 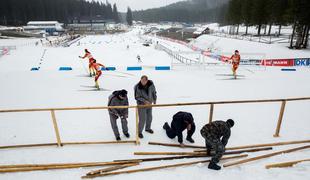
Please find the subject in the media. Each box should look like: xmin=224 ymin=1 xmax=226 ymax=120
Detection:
xmin=200 ymin=129 xmax=225 ymax=163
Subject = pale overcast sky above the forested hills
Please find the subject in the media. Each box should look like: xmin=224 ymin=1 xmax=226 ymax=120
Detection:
xmin=97 ymin=0 xmax=184 ymax=12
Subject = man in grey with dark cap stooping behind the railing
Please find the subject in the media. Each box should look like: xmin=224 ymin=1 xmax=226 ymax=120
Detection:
xmin=108 ymin=89 xmax=130 ymax=141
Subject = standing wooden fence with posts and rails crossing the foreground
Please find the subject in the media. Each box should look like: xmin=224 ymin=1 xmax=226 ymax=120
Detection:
xmin=0 ymin=97 xmax=310 ymax=149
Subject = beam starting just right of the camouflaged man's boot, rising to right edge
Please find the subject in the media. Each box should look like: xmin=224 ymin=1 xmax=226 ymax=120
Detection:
xmin=223 ymin=145 xmax=310 ymax=167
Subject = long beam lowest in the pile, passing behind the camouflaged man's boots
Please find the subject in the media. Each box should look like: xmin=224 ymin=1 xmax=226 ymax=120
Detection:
xmin=82 ymin=154 xmax=247 ymax=178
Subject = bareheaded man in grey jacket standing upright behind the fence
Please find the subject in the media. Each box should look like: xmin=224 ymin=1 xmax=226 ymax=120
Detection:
xmin=134 ymin=75 xmax=157 ymax=138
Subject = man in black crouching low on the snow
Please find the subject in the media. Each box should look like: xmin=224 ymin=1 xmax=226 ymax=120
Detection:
xmin=163 ymin=111 xmax=196 ymax=147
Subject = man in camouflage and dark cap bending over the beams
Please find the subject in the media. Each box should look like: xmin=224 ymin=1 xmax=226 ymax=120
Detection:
xmin=200 ymin=119 xmax=235 ymax=170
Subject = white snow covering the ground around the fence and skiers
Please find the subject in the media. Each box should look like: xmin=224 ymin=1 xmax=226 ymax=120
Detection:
xmin=0 ymin=30 xmax=310 ymax=180
